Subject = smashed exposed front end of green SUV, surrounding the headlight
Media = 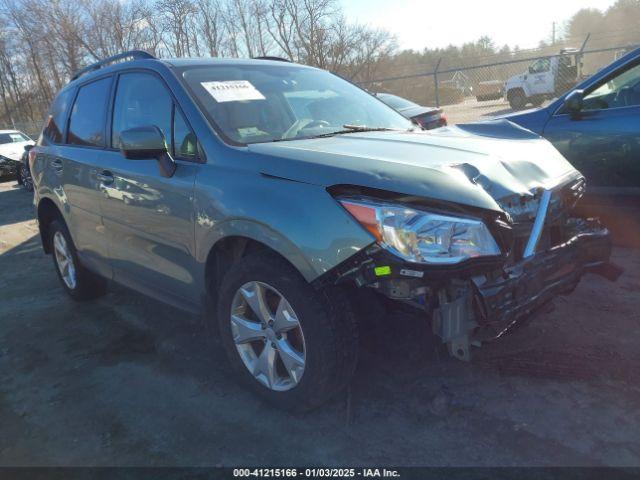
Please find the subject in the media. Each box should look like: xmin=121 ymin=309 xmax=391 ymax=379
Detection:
xmin=318 ymin=176 xmax=622 ymax=361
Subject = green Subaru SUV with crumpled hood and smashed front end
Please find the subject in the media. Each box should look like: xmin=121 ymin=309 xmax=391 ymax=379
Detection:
xmin=29 ymin=52 xmax=616 ymax=410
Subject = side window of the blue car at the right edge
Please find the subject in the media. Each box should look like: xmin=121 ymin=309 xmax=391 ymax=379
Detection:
xmin=584 ymin=64 xmax=640 ymax=110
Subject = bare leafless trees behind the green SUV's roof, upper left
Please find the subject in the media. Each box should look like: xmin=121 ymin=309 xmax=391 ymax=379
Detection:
xmin=0 ymin=0 xmax=396 ymax=124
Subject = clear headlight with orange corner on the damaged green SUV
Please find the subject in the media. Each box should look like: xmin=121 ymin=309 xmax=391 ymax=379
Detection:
xmin=340 ymin=199 xmax=500 ymax=264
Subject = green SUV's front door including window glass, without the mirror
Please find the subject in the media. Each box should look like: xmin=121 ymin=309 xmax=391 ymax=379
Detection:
xmin=100 ymin=70 xmax=200 ymax=306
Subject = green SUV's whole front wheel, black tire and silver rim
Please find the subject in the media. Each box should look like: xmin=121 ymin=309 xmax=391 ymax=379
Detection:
xmin=217 ymin=253 xmax=358 ymax=411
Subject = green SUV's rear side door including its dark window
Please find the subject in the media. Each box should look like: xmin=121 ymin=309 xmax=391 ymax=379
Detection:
xmin=57 ymin=76 xmax=113 ymax=277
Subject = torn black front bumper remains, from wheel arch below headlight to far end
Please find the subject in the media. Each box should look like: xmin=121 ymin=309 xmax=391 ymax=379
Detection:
xmin=316 ymin=213 xmax=621 ymax=360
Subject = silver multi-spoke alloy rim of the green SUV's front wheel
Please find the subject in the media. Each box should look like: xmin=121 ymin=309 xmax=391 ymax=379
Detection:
xmin=230 ymin=282 xmax=306 ymax=391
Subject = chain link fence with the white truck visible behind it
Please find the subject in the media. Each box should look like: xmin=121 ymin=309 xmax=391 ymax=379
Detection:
xmin=360 ymin=36 xmax=638 ymax=124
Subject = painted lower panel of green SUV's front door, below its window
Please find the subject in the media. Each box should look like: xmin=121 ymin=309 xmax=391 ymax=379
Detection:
xmin=100 ymin=151 xmax=200 ymax=302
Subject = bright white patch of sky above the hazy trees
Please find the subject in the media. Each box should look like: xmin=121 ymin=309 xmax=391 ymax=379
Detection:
xmin=340 ymin=0 xmax=615 ymax=50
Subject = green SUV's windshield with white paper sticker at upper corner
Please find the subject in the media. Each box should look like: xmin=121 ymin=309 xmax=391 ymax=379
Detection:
xmin=182 ymin=65 xmax=413 ymax=145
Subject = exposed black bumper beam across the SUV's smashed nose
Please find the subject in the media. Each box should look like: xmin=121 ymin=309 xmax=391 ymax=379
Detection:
xmin=432 ymin=219 xmax=621 ymax=360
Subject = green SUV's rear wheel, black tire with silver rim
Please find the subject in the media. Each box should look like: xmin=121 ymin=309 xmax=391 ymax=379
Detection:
xmin=48 ymin=219 xmax=107 ymax=301
